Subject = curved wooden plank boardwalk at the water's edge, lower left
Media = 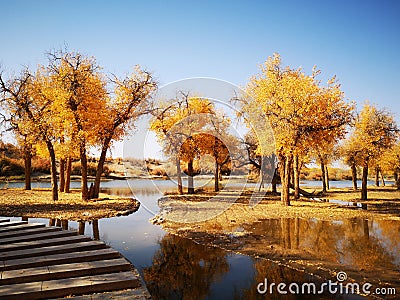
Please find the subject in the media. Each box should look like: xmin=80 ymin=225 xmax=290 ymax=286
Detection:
xmin=0 ymin=219 xmax=149 ymax=299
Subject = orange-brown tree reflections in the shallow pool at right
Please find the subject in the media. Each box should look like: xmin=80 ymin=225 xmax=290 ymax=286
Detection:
xmin=244 ymin=218 xmax=400 ymax=284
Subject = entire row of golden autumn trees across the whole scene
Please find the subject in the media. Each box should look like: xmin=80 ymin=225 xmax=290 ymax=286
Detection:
xmin=0 ymin=51 xmax=400 ymax=205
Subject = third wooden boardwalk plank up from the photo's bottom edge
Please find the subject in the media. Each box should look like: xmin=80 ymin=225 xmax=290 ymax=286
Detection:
xmin=0 ymin=258 xmax=132 ymax=285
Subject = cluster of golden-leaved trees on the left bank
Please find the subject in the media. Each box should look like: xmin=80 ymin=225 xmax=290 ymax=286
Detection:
xmin=0 ymin=51 xmax=157 ymax=200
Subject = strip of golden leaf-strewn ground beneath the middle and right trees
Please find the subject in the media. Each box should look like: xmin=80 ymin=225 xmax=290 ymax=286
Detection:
xmin=156 ymin=187 xmax=400 ymax=233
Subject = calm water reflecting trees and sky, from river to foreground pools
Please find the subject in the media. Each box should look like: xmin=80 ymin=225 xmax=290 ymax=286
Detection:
xmin=1 ymin=180 xmax=400 ymax=299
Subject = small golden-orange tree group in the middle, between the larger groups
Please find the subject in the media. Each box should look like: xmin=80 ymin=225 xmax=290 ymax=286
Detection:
xmin=150 ymin=91 xmax=238 ymax=194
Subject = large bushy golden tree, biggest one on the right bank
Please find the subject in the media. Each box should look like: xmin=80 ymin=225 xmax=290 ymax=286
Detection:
xmin=247 ymin=54 xmax=353 ymax=205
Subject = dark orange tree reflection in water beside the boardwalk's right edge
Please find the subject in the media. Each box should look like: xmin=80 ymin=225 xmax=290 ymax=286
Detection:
xmin=143 ymin=235 xmax=229 ymax=299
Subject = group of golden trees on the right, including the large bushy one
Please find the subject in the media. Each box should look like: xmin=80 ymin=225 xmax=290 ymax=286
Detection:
xmin=238 ymin=54 xmax=400 ymax=205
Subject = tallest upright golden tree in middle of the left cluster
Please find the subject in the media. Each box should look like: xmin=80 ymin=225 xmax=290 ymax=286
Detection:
xmin=46 ymin=51 xmax=108 ymax=200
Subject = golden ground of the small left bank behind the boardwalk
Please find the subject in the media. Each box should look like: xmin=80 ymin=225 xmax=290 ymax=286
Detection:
xmin=0 ymin=188 xmax=140 ymax=221
